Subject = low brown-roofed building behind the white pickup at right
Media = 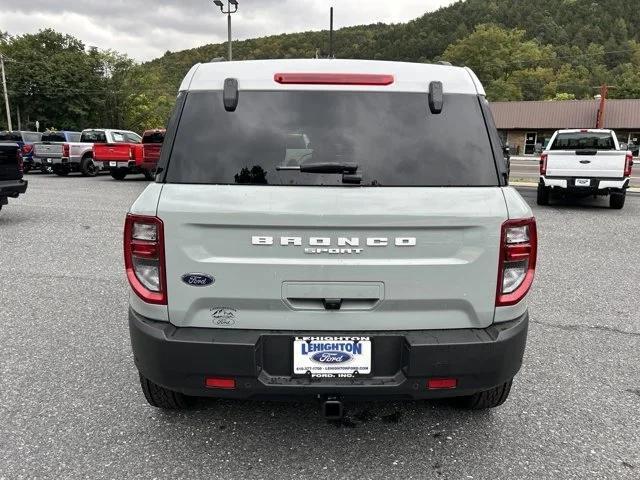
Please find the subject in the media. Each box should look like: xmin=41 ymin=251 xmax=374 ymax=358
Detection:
xmin=491 ymin=99 xmax=640 ymax=155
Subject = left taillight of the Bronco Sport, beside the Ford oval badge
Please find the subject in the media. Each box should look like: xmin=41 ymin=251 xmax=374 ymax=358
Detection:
xmin=124 ymin=214 xmax=167 ymax=305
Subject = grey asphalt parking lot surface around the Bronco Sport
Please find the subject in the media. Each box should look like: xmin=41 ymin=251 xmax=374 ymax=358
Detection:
xmin=0 ymin=174 xmax=640 ymax=479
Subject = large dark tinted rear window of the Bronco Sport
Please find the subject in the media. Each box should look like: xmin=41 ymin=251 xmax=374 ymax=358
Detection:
xmin=165 ymin=91 xmax=498 ymax=186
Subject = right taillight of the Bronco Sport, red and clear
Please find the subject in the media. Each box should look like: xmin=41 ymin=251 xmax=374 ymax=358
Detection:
xmin=496 ymin=218 xmax=538 ymax=307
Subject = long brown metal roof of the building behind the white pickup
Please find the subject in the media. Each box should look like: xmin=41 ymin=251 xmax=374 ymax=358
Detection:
xmin=491 ymin=99 xmax=640 ymax=130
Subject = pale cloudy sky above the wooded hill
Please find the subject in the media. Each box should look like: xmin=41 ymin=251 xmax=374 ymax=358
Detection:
xmin=0 ymin=0 xmax=453 ymax=61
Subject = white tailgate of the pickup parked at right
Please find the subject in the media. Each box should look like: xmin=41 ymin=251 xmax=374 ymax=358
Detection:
xmin=546 ymin=150 xmax=626 ymax=178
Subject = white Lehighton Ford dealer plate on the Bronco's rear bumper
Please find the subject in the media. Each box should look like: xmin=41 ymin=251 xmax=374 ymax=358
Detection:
xmin=293 ymin=337 xmax=371 ymax=378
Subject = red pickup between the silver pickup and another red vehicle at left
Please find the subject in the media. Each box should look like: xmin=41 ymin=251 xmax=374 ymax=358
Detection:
xmin=93 ymin=130 xmax=148 ymax=180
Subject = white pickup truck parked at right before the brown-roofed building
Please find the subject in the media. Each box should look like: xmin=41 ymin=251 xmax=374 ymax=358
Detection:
xmin=537 ymin=129 xmax=633 ymax=209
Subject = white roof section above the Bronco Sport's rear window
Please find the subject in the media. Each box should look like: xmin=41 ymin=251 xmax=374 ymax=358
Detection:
xmin=180 ymin=59 xmax=485 ymax=95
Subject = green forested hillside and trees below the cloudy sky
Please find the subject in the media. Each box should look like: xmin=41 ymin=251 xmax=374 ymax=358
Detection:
xmin=0 ymin=0 xmax=640 ymax=130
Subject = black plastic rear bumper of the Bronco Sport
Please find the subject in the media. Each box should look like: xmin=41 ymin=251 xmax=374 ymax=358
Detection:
xmin=129 ymin=309 xmax=529 ymax=399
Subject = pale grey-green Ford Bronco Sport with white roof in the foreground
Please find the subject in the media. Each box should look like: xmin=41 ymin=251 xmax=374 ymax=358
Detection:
xmin=124 ymin=60 xmax=537 ymax=418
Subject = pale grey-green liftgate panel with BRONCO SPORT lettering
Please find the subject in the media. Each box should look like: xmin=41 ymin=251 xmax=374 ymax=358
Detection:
xmin=158 ymin=184 xmax=507 ymax=331
